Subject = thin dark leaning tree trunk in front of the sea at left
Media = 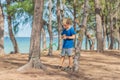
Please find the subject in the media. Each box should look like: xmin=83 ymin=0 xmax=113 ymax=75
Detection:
xmin=7 ymin=0 xmax=19 ymax=53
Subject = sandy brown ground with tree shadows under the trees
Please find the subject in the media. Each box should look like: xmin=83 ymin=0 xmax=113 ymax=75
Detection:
xmin=0 ymin=50 xmax=120 ymax=80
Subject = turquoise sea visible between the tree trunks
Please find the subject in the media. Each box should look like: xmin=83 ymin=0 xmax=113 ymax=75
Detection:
xmin=4 ymin=37 xmax=118 ymax=54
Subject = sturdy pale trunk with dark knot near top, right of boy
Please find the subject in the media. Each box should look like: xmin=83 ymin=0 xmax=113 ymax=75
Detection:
xmin=94 ymin=0 xmax=103 ymax=52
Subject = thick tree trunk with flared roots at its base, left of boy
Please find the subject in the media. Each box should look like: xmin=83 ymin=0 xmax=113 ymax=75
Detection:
xmin=18 ymin=0 xmax=46 ymax=71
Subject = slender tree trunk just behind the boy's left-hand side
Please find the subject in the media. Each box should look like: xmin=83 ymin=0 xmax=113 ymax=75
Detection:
xmin=57 ymin=0 xmax=62 ymax=50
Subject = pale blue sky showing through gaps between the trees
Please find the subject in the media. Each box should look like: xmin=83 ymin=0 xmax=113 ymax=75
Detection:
xmin=0 ymin=0 xmax=71 ymax=37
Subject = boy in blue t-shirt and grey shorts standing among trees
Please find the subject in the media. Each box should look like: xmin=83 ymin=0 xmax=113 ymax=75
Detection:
xmin=59 ymin=18 xmax=76 ymax=69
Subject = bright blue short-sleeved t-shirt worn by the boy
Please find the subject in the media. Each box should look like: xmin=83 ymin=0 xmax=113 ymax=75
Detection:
xmin=61 ymin=27 xmax=76 ymax=48
